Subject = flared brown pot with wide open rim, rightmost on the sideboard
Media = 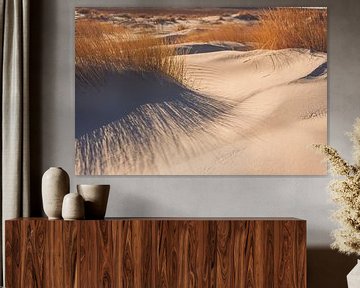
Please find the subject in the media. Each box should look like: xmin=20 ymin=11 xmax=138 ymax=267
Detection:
xmin=77 ymin=184 xmax=110 ymax=219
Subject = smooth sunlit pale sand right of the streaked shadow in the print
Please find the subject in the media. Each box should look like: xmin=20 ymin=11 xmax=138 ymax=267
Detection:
xmin=173 ymin=49 xmax=327 ymax=174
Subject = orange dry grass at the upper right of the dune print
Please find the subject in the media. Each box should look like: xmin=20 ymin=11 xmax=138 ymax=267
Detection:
xmin=183 ymin=8 xmax=327 ymax=52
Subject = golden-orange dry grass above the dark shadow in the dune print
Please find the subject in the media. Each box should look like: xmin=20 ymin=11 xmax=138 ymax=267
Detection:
xmin=75 ymin=20 xmax=185 ymax=83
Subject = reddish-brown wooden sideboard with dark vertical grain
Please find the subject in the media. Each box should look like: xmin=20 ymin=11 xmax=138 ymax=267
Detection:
xmin=5 ymin=218 xmax=306 ymax=288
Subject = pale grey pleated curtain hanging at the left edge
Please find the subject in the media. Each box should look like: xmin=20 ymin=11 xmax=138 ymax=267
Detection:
xmin=0 ymin=0 xmax=30 ymax=283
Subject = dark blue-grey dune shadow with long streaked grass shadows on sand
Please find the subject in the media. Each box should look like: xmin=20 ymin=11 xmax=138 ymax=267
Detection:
xmin=76 ymin=71 xmax=233 ymax=175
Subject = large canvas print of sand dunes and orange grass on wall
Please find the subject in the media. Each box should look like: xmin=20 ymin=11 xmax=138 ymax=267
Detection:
xmin=75 ymin=7 xmax=327 ymax=175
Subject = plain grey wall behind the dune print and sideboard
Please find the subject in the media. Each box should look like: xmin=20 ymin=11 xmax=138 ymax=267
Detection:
xmin=30 ymin=0 xmax=360 ymax=247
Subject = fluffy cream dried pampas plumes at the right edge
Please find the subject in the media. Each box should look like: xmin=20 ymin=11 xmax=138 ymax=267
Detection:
xmin=314 ymin=118 xmax=360 ymax=255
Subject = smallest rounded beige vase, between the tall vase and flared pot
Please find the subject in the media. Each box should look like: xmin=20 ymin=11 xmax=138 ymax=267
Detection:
xmin=61 ymin=192 xmax=85 ymax=220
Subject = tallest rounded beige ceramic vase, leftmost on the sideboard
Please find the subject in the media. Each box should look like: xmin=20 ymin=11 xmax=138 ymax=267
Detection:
xmin=41 ymin=167 xmax=70 ymax=219
